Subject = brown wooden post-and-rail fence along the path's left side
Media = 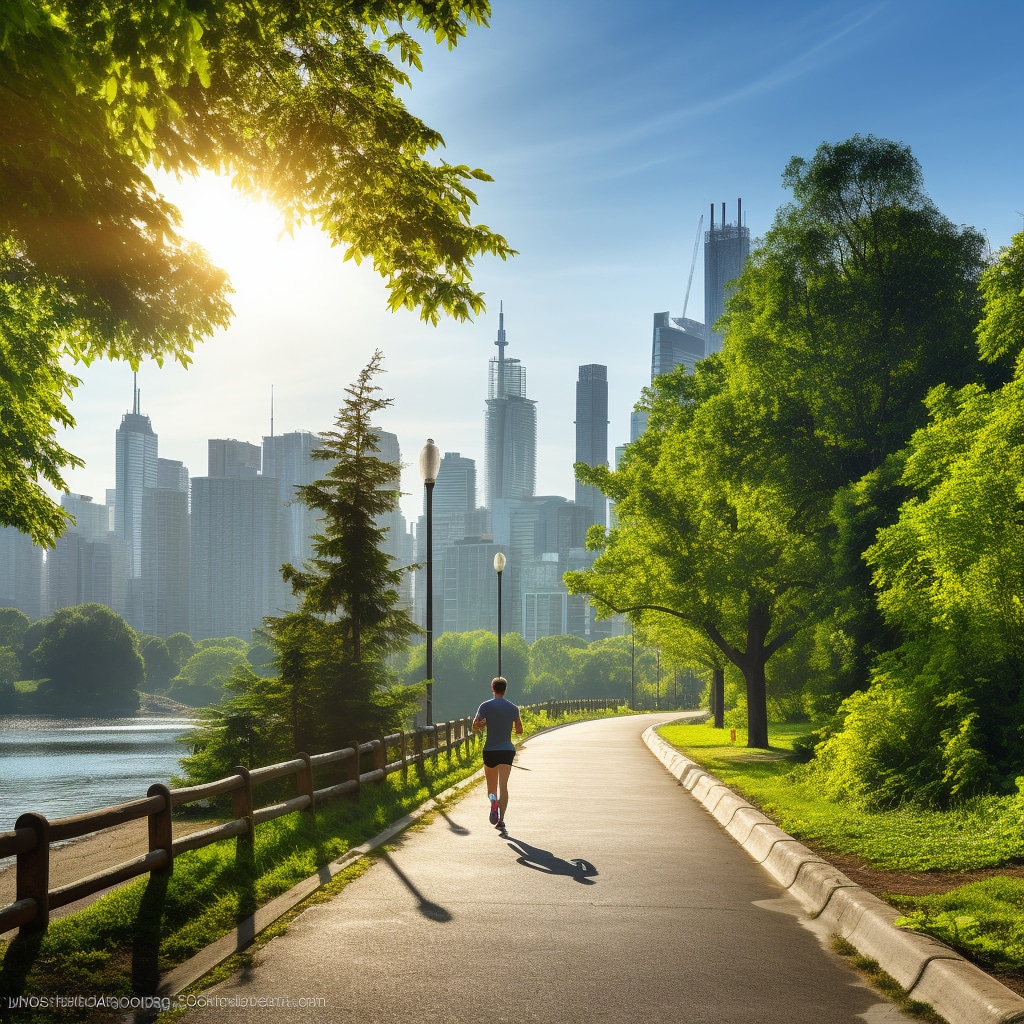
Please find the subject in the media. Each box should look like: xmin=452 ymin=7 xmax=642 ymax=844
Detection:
xmin=0 ymin=700 xmax=622 ymax=935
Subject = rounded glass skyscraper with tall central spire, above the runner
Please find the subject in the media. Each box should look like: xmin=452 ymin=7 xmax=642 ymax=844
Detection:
xmin=483 ymin=309 xmax=537 ymax=510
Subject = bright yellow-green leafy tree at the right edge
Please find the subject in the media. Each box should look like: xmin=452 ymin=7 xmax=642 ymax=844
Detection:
xmin=818 ymin=234 xmax=1024 ymax=806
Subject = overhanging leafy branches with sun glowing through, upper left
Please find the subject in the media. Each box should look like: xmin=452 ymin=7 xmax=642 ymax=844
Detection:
xmin=0 ymin=0 xmax=512 ymax=544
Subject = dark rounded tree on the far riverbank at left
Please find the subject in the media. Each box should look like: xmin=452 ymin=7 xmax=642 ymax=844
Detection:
xmin=32 ymin=604 xmax=143 ymax=715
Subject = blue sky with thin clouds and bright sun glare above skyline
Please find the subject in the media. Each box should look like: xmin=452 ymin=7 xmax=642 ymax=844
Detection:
xmin=58 ymin=0 xmax=1024 ymax=515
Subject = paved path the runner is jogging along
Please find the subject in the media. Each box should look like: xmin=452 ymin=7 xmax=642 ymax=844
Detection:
xmin=186 ymin=715 xmax=907 ymax=1024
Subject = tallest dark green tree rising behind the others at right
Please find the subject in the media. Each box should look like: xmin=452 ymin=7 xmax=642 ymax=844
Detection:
xmin=719 ymin=135 xmax=1007 ymax=712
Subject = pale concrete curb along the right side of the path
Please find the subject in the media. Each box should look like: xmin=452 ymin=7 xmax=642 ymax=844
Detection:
xmin=642 ymin=726 xmax=1024 ymax=1024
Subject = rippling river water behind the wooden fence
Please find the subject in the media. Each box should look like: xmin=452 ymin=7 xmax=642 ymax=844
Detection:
xmin=0 ymin=715 xmax=191 ymax=831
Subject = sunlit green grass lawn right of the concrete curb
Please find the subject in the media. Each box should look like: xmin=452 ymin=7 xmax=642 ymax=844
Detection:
xmin=658 ymin=725 xmax=1024 ymax=978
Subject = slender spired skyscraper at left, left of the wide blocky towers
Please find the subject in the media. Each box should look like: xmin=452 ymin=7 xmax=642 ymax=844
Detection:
xmin=114 ymin=388 xmax=158 ymax=632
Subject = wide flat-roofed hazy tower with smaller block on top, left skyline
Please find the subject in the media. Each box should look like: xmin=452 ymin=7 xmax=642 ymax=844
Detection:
xmin=188 ymin=440 xmax=290 ymax=641
